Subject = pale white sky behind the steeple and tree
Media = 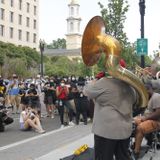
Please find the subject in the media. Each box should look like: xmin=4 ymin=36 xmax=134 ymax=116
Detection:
xmin=39 ymin=0 xmax=160 ymax=55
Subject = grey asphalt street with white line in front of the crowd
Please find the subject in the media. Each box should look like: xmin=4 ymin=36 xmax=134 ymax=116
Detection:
xmin=0 ymin=115 xmax=160 ymax=160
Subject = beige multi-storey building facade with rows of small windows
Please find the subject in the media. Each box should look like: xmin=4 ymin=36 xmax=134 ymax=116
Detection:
xmin=0 ymin=0 xmax=39 ymax=50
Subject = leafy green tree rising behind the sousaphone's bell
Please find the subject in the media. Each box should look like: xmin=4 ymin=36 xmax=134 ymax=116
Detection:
xmin=95 ymin=0 xmax=151 ymax=70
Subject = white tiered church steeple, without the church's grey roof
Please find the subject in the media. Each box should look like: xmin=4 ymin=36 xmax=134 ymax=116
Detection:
xmin=66 ymin=0 xmax=82 ymax=49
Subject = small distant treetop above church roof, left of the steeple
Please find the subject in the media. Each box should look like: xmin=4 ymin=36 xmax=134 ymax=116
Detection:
xmin=47 ymin=38 xmax=66 ymax=49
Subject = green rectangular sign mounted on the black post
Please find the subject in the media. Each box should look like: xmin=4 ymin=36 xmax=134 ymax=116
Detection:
xmin=137 ymin=38 xmax=148 ymax=56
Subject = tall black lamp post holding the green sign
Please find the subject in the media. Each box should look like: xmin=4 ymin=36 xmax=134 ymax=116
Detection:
xmin=139 ymin=0 xmax=146 ymax=68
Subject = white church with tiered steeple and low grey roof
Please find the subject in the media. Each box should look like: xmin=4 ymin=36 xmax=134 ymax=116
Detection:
xmin=44 ymin=0 xmax=82 ymax=57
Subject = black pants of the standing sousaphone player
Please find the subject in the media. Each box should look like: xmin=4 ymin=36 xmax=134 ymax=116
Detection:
xmin=94 ymin=135 xmax=131 ymax=160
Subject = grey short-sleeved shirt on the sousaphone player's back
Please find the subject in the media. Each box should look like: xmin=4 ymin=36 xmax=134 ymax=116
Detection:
xmin=84 ymin=77 xmax=136 ymax=139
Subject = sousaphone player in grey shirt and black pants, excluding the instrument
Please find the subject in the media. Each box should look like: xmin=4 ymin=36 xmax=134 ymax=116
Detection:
xmin=84 ymin=77 xmax=136 ymax=160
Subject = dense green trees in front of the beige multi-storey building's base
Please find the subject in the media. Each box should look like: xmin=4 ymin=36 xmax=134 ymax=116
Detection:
xmin=0 ymin=42 xmax=40 ymax=77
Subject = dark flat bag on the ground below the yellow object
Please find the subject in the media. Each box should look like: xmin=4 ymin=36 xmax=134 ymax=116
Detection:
xmin=60 ymin=148 xmax=95 ymax=160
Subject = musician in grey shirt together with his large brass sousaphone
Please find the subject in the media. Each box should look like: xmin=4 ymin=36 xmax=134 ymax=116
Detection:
xmin=82 ymin=16 xmax=148 ymax=160
